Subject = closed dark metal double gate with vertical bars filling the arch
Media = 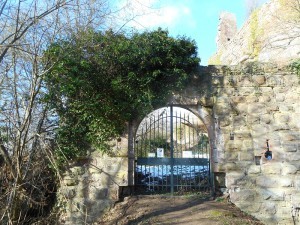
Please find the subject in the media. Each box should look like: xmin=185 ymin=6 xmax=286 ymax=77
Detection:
xmin=135 ymin=106 xmax=211 ymax=194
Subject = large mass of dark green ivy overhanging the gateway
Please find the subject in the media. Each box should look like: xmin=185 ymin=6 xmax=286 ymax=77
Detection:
xmin=44 ymin=29 xmax=199 ymax=163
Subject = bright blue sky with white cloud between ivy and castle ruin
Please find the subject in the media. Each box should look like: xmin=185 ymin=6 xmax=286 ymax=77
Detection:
xmin=112 ymin=0 xmax=267 ymax=65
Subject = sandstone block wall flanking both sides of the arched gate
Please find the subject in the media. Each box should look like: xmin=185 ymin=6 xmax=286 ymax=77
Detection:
xmin=59 ymin=63 xmax=300 ymax=225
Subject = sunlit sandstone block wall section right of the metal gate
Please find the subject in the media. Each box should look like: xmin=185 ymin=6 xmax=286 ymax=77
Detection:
xmin=203 ymin=64 xmax=300 ymax=224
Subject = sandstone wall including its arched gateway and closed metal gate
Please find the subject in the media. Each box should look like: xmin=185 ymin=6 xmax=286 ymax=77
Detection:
xmin=60 ymin=64 xmax=300 ymax=225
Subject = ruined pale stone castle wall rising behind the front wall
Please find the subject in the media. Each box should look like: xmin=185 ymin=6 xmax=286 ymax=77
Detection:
xmin=208 ymin=0 xmax=300 ymax=65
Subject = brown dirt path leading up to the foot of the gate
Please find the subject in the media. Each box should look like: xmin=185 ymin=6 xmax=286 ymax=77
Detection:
xmin=95 ymin=195 xmax=262 ymax=225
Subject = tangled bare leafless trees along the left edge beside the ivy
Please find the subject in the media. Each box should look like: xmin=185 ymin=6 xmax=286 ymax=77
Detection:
xmin=0 ymin=0 xmax=115 ymax=224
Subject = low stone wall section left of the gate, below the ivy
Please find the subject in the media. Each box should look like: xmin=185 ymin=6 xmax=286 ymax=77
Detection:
xmin=58 ymin=136 xmax=129 ymax=225
